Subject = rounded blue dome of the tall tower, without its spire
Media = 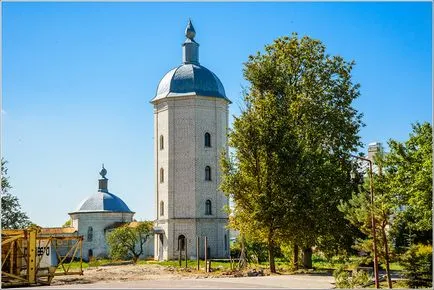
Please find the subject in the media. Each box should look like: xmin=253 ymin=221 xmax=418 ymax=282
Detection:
xmin=152 ymin=63 xmax=229 ymax=101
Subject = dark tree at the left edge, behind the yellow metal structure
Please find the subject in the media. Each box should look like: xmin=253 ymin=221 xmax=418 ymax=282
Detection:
xmin=1 ymin=158 xmax=30 ymax=229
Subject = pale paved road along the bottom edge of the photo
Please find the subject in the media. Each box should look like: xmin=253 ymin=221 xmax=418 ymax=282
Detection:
xmin=38 ymin=275 xmax=334 ymax=289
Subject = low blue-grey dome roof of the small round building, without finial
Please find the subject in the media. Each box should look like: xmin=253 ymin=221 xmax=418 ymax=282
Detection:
xmin=76 ymin=191 xmax=132 ymax=212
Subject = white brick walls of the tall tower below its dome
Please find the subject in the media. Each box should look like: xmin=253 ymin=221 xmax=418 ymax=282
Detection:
xmin=154 ymin=96 xmax=229 ymax=260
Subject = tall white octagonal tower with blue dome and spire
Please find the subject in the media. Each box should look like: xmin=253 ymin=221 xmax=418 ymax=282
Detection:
xmin=151 ymin=21 xmax=231 ymax=260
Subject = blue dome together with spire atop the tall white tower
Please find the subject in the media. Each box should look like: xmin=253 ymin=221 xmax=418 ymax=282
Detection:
xmin=151 ymin=21 xmax=230 ymax=102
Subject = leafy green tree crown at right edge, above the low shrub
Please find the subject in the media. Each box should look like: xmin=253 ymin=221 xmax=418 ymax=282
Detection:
xmin=384 ymin=122 xmax=432 ymax=244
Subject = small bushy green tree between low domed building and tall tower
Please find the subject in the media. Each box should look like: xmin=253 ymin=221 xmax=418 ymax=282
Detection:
xmin=107 ymin=221 xmax=152 ymax=263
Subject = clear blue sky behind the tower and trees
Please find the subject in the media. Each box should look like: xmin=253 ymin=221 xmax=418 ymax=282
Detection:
xmin=1 ymin=2 xmax=432 ymax=226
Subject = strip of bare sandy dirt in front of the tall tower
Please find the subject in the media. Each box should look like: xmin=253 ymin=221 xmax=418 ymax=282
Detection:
xmin=51 ymin=264 xmax=228 ymax=286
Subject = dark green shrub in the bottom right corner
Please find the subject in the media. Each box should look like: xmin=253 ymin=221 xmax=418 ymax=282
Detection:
xmin=401 ymin=244 xmax=433 ymax=288
